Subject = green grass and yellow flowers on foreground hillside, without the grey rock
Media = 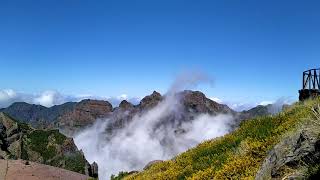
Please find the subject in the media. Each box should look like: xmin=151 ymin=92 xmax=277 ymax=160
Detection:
xmin=117 ymin=99 xmax=320 ymax=179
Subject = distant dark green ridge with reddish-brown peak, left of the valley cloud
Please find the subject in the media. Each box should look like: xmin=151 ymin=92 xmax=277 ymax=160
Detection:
xmin=0 ymin=99 xmax=112 ymax=131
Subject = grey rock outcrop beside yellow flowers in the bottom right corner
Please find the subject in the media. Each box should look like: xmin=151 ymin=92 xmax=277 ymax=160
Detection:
xmin=256 ymin=128 xmax=320 ymax=180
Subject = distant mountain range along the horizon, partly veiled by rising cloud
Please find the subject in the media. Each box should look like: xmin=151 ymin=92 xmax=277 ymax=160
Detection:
xmin=0 ymin=90 xmax=270 ymax=135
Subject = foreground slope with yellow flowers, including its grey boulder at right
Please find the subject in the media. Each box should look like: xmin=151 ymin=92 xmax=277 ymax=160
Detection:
xmin=115 ymin=99 xmax=320 ymax=179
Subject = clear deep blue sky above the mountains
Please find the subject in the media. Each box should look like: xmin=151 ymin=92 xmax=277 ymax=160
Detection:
xmin=0 ymin=0 xmax=320 ymax=108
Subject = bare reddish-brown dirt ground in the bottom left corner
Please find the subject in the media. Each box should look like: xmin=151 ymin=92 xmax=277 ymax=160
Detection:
xmin=0 ymin=160 xmax=88 ymax=180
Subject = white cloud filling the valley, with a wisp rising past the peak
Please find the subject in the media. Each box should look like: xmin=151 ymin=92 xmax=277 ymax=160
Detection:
xmin=74 ymin=71 xmax=233 ymax=180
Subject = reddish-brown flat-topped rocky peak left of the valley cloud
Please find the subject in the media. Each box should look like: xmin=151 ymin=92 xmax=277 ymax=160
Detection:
xmin=57 ymin=99 xmax=112 ymax=134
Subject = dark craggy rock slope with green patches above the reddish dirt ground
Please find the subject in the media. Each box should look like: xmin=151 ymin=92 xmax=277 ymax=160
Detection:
xmin=0 ymin=113 xmax=97 ymax=177
